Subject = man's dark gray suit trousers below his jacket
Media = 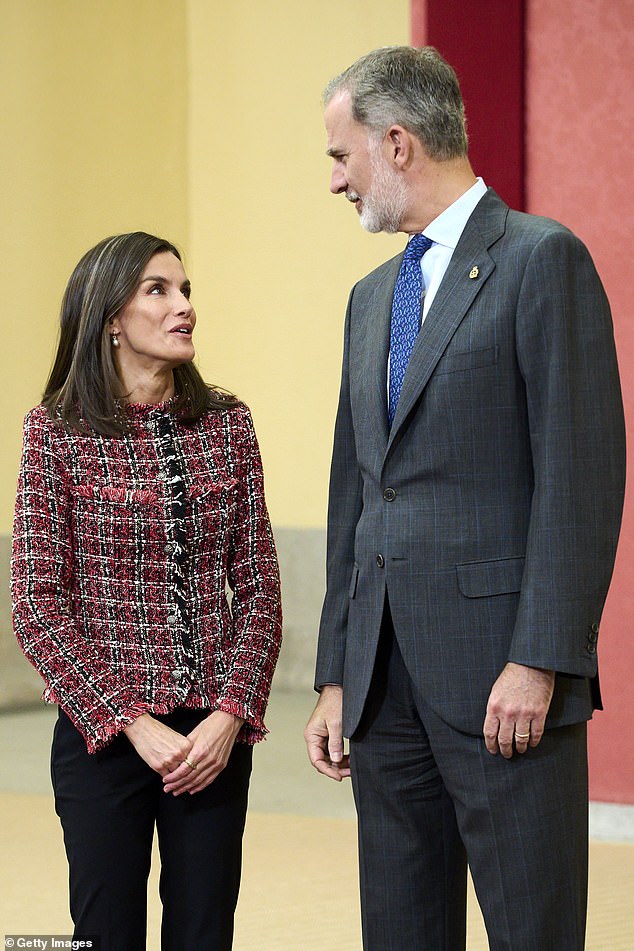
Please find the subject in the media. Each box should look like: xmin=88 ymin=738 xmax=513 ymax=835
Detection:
xmin=350 ymin=606 xmax=588 ymax=951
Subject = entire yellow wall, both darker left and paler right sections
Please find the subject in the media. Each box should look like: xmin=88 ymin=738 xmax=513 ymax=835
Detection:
xmin=0 ymin=0 xmax=409 ymax=532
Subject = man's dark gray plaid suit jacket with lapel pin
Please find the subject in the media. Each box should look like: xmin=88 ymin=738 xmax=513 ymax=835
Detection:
xmin=315 ymin=190 xmax=625 ymax=736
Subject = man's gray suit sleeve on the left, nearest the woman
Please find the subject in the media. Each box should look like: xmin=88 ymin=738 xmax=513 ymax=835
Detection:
xmin=315 ymin=288 xmax=363 ymax=690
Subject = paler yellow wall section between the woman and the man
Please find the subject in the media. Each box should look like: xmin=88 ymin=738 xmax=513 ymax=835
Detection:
xmin=189 ymin=0 xmax=409 ymax=527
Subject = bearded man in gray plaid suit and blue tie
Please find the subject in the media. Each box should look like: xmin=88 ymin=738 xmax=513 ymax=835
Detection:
xmin=305 ymin=47 xmax=624 ymax=951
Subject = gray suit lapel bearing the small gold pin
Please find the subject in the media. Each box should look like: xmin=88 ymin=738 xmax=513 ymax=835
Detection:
xmin=387 ymin=190 xmax=508 ymax=451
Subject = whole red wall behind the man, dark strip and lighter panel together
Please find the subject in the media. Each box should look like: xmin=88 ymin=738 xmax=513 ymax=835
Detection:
xmin=411 ymin=0 xmax=634 ymax=803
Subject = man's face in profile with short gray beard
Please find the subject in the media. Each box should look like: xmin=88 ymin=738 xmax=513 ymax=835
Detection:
xmin=324 ymin=93 xmax=407 ymax=233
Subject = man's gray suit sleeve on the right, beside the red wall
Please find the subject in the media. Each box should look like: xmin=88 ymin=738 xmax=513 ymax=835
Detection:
xmin=509 ymin=228 xmax=625 ymax=677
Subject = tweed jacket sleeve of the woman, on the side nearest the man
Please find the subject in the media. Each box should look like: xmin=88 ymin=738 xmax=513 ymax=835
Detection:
xmin=216 ymin=409 xmax=282 ymax=742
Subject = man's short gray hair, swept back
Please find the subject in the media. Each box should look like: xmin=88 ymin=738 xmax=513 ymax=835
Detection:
xmin=323 ymin=46 xmax=467 ymax=162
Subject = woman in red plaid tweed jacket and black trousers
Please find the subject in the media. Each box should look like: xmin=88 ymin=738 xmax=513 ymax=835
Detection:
xmin=12 ymin=232 xmax=281 ymax=951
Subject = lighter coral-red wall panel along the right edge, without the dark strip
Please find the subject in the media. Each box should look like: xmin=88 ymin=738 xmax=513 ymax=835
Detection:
xmin=526 ymin=0 xmax=634 ymax=803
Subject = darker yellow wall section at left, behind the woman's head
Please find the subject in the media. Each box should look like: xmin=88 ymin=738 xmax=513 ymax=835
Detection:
xmin=0 ymin=0 xmax=188 ymax=533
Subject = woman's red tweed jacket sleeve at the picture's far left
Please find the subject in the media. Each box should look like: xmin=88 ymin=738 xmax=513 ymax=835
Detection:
xmin=11 ymin=409 xmax=147 ymax=752
